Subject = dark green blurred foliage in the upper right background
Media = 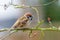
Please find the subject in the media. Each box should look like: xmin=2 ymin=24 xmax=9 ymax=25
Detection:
xmin=44 ymin=0 xmax=60 ymax=21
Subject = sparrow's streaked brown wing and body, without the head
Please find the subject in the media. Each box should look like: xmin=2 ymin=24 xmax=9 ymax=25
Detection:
xmin=12 ymin=16 xmax=28 ymax=28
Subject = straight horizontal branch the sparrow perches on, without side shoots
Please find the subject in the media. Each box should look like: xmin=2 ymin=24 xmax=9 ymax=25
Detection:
xmin=0 ymin=28 xmax=60 ymax=32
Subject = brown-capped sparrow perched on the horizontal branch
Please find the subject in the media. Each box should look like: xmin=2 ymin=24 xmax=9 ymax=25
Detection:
xmin=12 ymin=12 xmax=33 ymax=29
